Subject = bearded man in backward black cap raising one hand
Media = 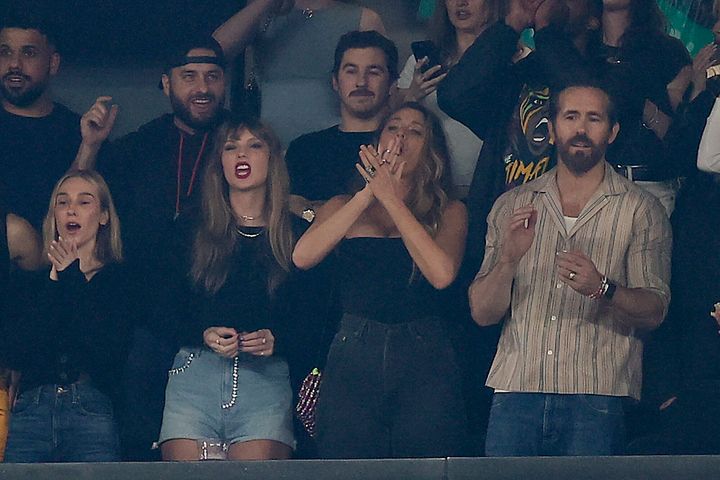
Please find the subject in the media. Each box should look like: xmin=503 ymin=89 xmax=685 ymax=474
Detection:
xmin=76 ymin=36 xmax=225 ymax=460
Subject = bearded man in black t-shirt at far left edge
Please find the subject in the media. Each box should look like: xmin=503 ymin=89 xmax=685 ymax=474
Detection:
xmin=0 ymin=11 xmax=80 ymax=229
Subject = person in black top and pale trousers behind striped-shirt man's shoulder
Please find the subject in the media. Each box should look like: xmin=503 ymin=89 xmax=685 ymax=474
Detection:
xmin=600 ymin=0 xmax=692 ymax=216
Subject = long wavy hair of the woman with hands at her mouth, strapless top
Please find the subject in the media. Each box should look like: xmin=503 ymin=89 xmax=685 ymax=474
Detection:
xmin=378 ymin=102 xmax=453 ymax=236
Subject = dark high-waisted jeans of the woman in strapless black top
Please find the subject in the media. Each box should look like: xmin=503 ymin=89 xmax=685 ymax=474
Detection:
xmin=317 ymin=314 xmax=467 ymax=458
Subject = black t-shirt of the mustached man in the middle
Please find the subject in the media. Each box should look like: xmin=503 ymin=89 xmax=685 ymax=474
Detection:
xmin=285 ymin=125 xmax=375 ymax=200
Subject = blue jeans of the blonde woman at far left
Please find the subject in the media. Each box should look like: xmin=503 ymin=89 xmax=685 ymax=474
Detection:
xmin=5 ymin=384 xmax=120 ymax=463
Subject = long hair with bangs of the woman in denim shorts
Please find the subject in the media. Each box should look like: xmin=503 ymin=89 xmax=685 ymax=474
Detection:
xmin=190 ymin=117 xmax=295 ymax=293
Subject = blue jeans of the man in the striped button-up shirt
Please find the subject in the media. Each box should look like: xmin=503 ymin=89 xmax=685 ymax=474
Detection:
xmin=485 ymin=393 xmax=625 ymax=457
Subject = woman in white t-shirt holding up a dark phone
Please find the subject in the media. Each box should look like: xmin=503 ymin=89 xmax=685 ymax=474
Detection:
xmin=398 ymin=0 xmax=502 ymax=198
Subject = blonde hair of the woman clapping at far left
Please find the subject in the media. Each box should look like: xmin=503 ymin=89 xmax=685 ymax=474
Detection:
xmin=43 ymin=170 xmax=123 ymax=265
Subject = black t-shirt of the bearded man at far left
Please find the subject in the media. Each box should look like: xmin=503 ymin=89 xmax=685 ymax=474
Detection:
xmin=0 ymin=103 xmax=81 ymax=230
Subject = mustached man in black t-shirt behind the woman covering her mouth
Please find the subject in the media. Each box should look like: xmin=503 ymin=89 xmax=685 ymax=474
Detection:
xmin=285 ymin=31 xmax=398 ymax=206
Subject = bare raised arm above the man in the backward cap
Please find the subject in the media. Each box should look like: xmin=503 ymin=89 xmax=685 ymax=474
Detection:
xmin=213 ymin=0 xmax=292 ymax=58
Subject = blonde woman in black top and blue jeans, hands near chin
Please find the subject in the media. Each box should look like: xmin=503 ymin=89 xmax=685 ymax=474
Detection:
xmin=6 ymin=171 xmax=133 ymax=463
